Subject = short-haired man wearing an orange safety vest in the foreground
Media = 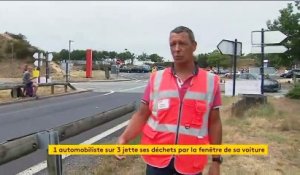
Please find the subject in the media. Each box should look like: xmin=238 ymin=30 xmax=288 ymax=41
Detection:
xmin=117 ymin=26 xmax=222 ymax=175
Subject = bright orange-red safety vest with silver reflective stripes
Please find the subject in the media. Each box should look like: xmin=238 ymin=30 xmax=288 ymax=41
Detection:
xmin=141 ymin=68 xmax=219 ymax=174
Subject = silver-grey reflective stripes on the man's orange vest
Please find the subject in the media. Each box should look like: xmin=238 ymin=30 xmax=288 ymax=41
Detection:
xmin=147 ymin=71 xmax=214 ymax=138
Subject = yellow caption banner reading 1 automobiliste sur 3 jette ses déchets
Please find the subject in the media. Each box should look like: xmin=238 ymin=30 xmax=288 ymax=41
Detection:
xmin=48 ymin=144 xmax=269 ymax=155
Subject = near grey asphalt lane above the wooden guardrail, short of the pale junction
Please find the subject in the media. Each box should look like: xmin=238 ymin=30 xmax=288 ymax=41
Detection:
xmin=0 ymin=92 xmax=140 ymax=142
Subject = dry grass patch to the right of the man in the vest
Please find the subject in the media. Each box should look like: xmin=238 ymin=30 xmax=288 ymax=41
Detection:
xmin=222 ymin=97 xmax=300 ymax=175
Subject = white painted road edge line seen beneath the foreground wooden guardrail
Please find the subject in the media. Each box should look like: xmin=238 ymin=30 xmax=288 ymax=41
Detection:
xmin=17 ymin=120 xmax=129 ymax=175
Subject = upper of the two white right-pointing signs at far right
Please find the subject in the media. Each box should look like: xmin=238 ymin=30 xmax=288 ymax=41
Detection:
xmin=251 ymin=30 xmax=287 ymax=45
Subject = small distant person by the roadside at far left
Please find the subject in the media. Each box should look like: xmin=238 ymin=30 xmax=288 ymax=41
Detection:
xmin=23 ymin=64 xmax=38 ymax=97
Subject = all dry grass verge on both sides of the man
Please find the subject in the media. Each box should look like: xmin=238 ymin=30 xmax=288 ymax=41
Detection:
xmin=62 ymin=97 xmax=300 ymax=175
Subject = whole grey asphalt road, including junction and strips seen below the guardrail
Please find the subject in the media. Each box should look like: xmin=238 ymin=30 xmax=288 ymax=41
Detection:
xmin=0 ymin=81 xmax=147 ymax=174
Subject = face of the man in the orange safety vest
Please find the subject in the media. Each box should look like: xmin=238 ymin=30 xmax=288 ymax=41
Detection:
xmin=169 ymin=32 xmax=197 ymax=63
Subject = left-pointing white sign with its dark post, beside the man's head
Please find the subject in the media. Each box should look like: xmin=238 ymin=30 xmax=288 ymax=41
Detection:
xmin=217 ymin=39 xmax=242 ymax=96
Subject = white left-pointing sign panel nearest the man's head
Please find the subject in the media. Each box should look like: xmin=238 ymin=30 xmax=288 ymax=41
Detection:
xmin=217 ymin=40 xmax=242 ymax=56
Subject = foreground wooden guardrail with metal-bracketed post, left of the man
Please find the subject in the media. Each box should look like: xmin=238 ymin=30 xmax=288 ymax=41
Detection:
xmin=0 ymin=102 xmax=135 ymax=174
